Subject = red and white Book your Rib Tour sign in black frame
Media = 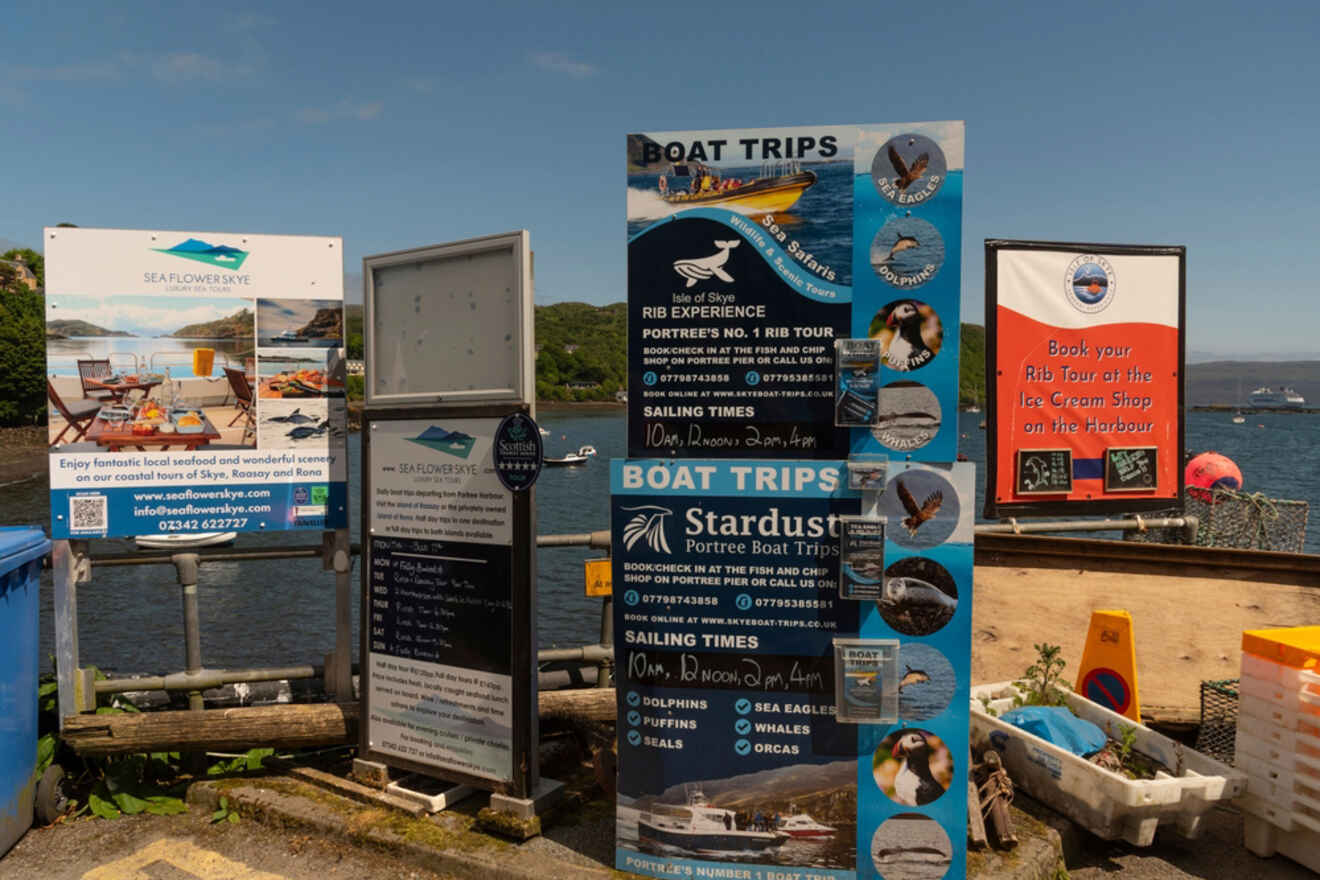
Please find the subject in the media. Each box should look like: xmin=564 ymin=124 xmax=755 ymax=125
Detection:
xmin=986 ymin=240 xmax=1185 ymax=519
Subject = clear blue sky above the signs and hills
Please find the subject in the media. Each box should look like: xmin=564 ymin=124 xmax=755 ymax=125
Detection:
xmin=0 ymin=0 xmax=1320 ymax=359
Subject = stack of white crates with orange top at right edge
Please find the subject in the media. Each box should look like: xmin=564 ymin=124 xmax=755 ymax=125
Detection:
xmin=1236 ymin=627 xmax=1320 ymax=872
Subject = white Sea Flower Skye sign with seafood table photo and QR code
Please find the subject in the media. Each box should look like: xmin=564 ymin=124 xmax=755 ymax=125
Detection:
xmin=45 ymin=228 xmax=347 ymax=538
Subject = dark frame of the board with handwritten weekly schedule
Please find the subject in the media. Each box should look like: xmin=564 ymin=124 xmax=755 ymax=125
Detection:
xmin=358 ymin=405 xmax=540 ymax=798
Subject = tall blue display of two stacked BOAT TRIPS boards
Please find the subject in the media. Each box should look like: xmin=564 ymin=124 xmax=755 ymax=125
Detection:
xmin=611 ymin=123 xmax=974 ymax=880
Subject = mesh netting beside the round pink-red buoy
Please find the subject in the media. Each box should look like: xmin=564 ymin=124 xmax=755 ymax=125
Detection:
xmin=1123 ymin=488 xmax=1311 ymax=553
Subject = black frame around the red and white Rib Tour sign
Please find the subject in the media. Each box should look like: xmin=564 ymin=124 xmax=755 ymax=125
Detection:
xmin=983 ymin=239 xmax=1187 ymax=520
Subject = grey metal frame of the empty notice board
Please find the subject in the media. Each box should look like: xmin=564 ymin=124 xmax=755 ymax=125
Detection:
xmin=362 ymin=230 xmax=536 ymax=418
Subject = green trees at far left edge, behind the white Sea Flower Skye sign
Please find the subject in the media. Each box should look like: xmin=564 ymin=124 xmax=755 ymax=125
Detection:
xmin=0 ymin=287 xmax=46 ymax=425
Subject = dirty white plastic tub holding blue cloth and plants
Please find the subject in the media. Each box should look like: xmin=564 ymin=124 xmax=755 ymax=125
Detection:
xmin=972 ymin=682 xmax=1246 ymax=846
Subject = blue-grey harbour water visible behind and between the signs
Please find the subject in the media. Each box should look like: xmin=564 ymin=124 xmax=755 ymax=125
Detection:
xmin=0 ymin=408 xmax=1320 ymax=680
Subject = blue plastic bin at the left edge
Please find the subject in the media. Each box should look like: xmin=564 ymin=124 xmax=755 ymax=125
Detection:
xmin=0 ymin=525 xmax=50 ymax=855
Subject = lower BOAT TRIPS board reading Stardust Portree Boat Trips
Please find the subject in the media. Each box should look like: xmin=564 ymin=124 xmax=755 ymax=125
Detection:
xmin=611 ymin=459 xmax=973 ymax=880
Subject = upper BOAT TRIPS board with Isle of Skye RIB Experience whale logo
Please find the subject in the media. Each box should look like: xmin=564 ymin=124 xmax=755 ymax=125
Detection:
xmin=627 ymin=123 xmax=962 ymax=460
